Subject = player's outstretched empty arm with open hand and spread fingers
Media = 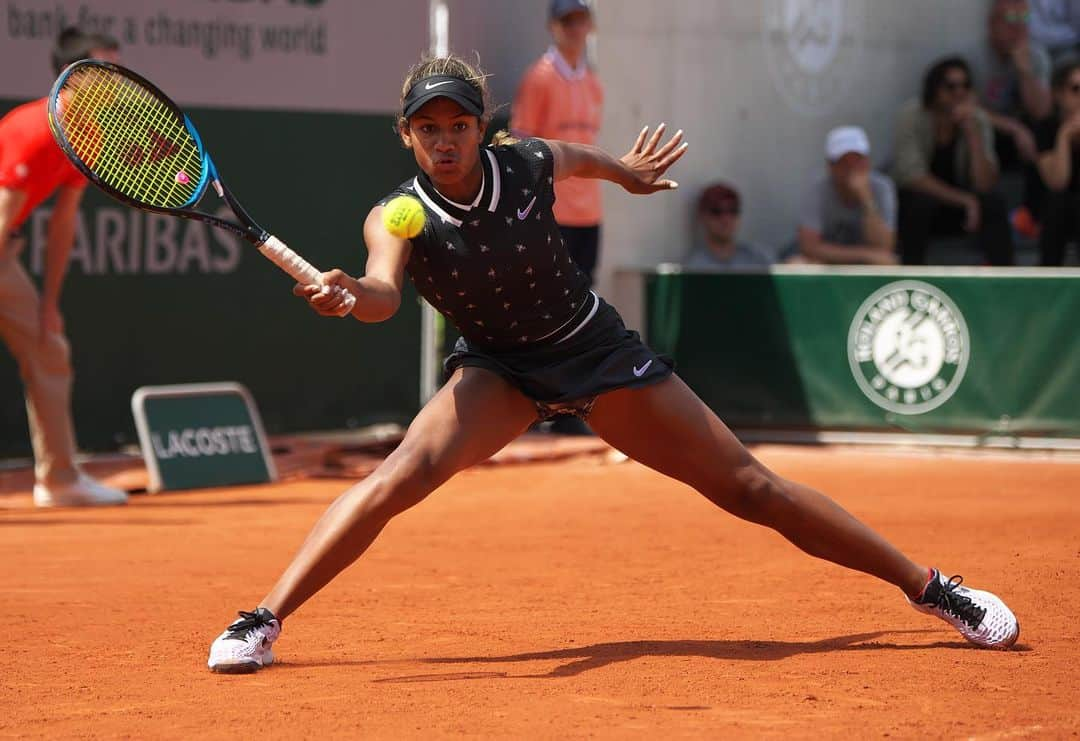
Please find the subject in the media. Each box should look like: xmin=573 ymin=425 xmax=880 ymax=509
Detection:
xmin=545 ymin=123 xmax=689 ymax=193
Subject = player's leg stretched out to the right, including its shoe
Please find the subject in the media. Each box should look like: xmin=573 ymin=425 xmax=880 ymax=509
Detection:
xmin=589 ymin=376 xmax=1020 ymax=647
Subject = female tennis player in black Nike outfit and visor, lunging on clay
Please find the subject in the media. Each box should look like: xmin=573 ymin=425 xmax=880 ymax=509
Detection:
xmin=208 ymin=57 xmax=1020 ymax=673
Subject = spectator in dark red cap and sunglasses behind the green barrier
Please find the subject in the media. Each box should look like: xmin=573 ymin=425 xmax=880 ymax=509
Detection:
xmin=683 ymin=183 xmax=772 ymax=270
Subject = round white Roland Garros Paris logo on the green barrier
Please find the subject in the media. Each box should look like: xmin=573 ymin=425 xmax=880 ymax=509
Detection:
xmin=848 ymin=281 xmax=971 ymax=415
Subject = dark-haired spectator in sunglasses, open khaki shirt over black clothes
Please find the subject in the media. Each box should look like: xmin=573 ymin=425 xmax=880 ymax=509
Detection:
xmin=894 ymin=57 xmax=1013 ymax=265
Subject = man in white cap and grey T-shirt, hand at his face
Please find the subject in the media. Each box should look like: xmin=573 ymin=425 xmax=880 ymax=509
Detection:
xmin=794 ymin=126 xmax=897 ymax=265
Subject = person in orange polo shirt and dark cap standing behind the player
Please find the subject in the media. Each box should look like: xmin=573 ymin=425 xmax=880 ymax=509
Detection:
xmin=510 ymin=0 xmax=604 ymax=284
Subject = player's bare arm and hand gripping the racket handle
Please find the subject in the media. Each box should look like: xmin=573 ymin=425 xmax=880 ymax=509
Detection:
xmin=293 ymin=206 xmax=413 ymax=322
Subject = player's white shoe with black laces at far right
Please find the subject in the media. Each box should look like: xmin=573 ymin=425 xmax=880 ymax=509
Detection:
xmin=908 ymin=569 xmax=1020 ymax=648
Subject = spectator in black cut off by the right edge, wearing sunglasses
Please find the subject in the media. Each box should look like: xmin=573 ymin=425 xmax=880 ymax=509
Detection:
xmin=1036 ymin=60 xmax=1080 ymax=266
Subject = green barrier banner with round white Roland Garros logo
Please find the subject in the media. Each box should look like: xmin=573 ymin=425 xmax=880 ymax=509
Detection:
xmin=646 ymin=268 xmax=1080 ymax=436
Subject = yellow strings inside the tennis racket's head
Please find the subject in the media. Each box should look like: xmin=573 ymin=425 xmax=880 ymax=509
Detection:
xmin=57 ymin=68 xmax=203 ymax=208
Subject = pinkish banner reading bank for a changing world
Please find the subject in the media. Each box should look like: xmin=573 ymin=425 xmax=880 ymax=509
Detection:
xmin=0 ymin=0 xmax=428 ymax=112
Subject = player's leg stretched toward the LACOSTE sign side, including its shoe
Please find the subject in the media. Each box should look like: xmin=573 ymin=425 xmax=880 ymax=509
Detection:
xmin=210 ymin=367 xmax=537 ymax=673
